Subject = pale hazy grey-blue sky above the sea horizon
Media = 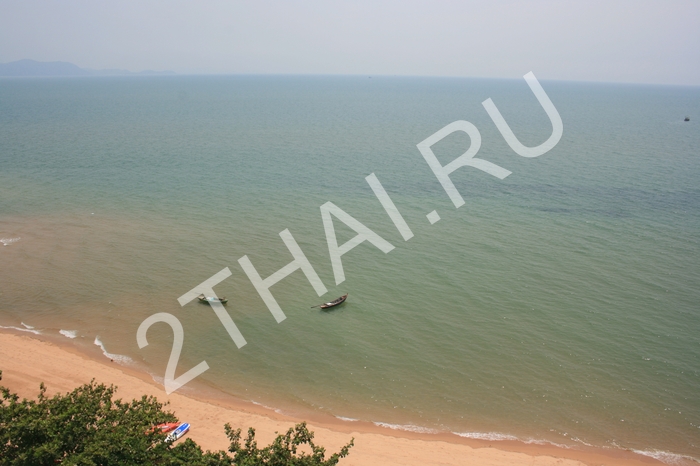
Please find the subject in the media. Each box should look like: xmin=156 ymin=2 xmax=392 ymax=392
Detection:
xmin=0 ymin=0 xmax=700 ymax=85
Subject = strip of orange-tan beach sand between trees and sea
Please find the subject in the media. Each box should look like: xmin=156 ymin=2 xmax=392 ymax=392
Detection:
xmin=0 ymin=332 xmax=663 ymax=466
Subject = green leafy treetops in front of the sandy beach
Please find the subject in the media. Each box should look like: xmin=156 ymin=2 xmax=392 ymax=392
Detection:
xmin=0 ymin=371 xmax=353 ymax=466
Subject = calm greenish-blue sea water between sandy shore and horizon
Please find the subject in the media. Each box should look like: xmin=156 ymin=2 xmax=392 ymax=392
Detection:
xmin=0 ymin=75 xmax=700 ymax=462
